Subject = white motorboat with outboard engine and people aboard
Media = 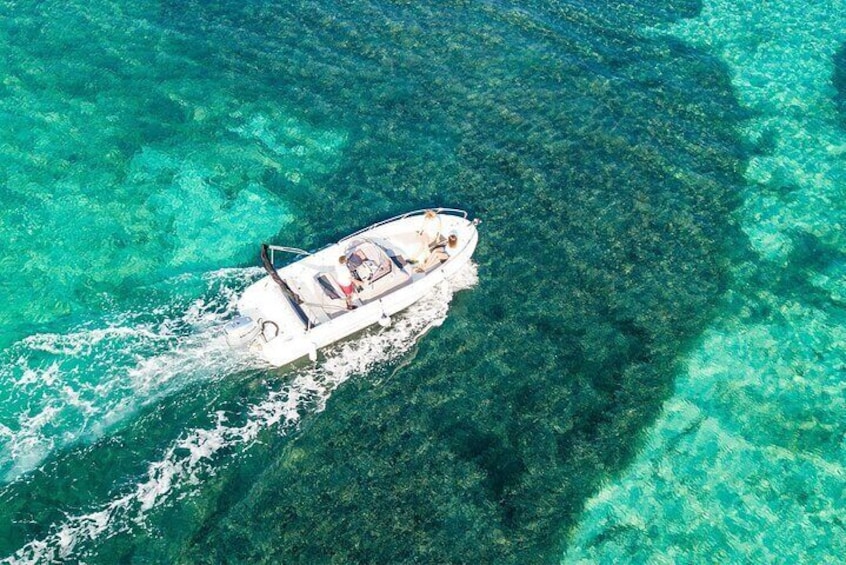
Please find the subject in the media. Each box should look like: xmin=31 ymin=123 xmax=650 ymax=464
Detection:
xmin=225 ymin=208 xmax=479 ymax=367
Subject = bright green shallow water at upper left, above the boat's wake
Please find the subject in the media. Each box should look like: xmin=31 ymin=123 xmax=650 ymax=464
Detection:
xmin=0 ymin=2 xmax=346 ymax=346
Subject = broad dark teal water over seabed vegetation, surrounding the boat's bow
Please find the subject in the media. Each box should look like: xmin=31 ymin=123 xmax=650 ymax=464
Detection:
xmin=0 ymin=1 xmax=746 ymax=563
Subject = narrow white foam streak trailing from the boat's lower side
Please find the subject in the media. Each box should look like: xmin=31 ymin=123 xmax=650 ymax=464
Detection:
xmin=2 ymin=264 xmax=478 ymax=564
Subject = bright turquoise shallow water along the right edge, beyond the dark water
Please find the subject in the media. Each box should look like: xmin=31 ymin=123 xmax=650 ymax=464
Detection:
xmin=564 ymin=1 xmax=846 ymax=563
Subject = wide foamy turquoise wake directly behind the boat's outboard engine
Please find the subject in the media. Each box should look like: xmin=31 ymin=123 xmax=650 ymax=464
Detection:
xmin=0 ymin=269 xmax=259 ymax=481
